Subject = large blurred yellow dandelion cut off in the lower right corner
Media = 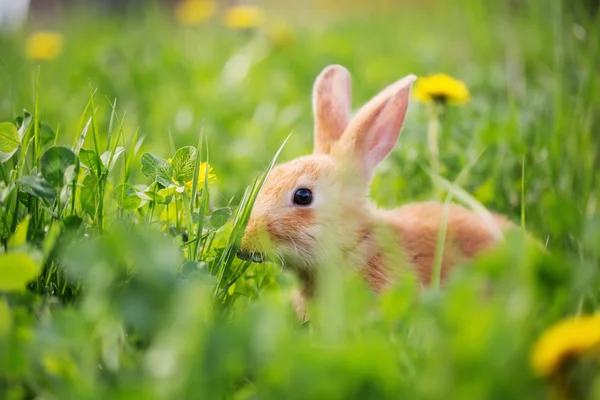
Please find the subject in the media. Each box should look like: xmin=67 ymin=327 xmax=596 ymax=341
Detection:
xmin=531 ymin=313 xmax=600 ymax=376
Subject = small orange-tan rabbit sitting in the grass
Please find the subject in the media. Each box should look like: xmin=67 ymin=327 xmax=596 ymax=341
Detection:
xmin=238 ymin=65 xmax=510 ymax=313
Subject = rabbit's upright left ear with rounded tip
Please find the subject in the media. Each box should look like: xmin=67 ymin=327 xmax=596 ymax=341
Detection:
xmin=313 ymin=65 xmax=351 ymax=154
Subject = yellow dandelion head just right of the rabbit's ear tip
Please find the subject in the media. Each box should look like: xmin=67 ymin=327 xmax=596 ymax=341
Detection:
xmin=413 ymin=74 xmax=470 ymax=104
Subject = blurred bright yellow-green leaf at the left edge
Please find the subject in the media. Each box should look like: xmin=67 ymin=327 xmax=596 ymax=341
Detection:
xmin=0 ymin=253 xmax=38 ymax=292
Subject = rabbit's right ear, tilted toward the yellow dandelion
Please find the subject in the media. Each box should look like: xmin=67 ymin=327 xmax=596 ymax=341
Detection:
xmin=332 ymin=75 xmax=417 ymax=179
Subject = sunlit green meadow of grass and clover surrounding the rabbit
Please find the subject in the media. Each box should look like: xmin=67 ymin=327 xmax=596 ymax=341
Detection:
xmin=0 ymin=0 xmax=600 ymax=400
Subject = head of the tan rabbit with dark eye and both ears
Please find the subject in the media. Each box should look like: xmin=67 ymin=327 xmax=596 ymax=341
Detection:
xmin=239 ymin=65 xmax=416 ymax=269
